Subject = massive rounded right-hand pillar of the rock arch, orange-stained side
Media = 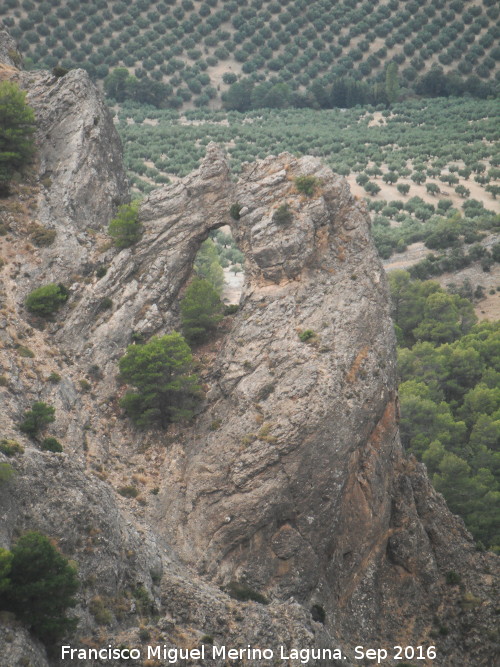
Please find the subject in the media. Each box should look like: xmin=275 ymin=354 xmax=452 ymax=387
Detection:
xmin=154 ymin=154 xmax=400 ymax=600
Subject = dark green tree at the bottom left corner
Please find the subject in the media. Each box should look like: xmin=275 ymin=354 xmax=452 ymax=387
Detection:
xmin=0 ymin=532 xmax=78 ymax=646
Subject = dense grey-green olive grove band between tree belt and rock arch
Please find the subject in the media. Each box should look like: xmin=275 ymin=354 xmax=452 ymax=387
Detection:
xmin=118 ymin=98 xmax=498 ymax=199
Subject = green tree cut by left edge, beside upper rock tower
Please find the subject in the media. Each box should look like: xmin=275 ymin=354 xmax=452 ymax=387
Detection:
xmin=0 ymin=81 xmax=35 ymax=193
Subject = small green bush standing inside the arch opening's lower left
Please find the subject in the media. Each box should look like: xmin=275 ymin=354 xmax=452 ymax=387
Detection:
xmin=180 ymin=278 xmax=223 ymax=343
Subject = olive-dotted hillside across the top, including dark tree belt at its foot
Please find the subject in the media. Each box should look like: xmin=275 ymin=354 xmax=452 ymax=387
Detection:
xmin=4 ymin=0 xmax=500 ymax=109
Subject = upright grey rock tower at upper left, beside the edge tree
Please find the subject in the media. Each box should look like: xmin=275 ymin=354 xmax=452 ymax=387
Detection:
xmin=21 ymin=70 xmax=128 ymax=234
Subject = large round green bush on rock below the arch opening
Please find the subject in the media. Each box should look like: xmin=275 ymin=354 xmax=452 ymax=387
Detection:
xmin=119 ymin=332 xmax=201 ymax=427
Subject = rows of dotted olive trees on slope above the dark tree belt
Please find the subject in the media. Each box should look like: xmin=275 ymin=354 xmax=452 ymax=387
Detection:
xmin=5 ymin=0 xmax=500 ymax=108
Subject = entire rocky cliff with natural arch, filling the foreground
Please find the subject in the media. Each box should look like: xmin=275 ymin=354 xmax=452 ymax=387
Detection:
xmin=0 ymin=35 xmax=498 ymax=666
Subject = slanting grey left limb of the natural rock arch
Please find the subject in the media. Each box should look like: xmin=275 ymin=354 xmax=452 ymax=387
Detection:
xmin=58 ymin=146 xmax=232 ymax=364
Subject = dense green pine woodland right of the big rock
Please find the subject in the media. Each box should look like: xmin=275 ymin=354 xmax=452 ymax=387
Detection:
xmin=389 ymin=271 xmax=500 ymax=551
